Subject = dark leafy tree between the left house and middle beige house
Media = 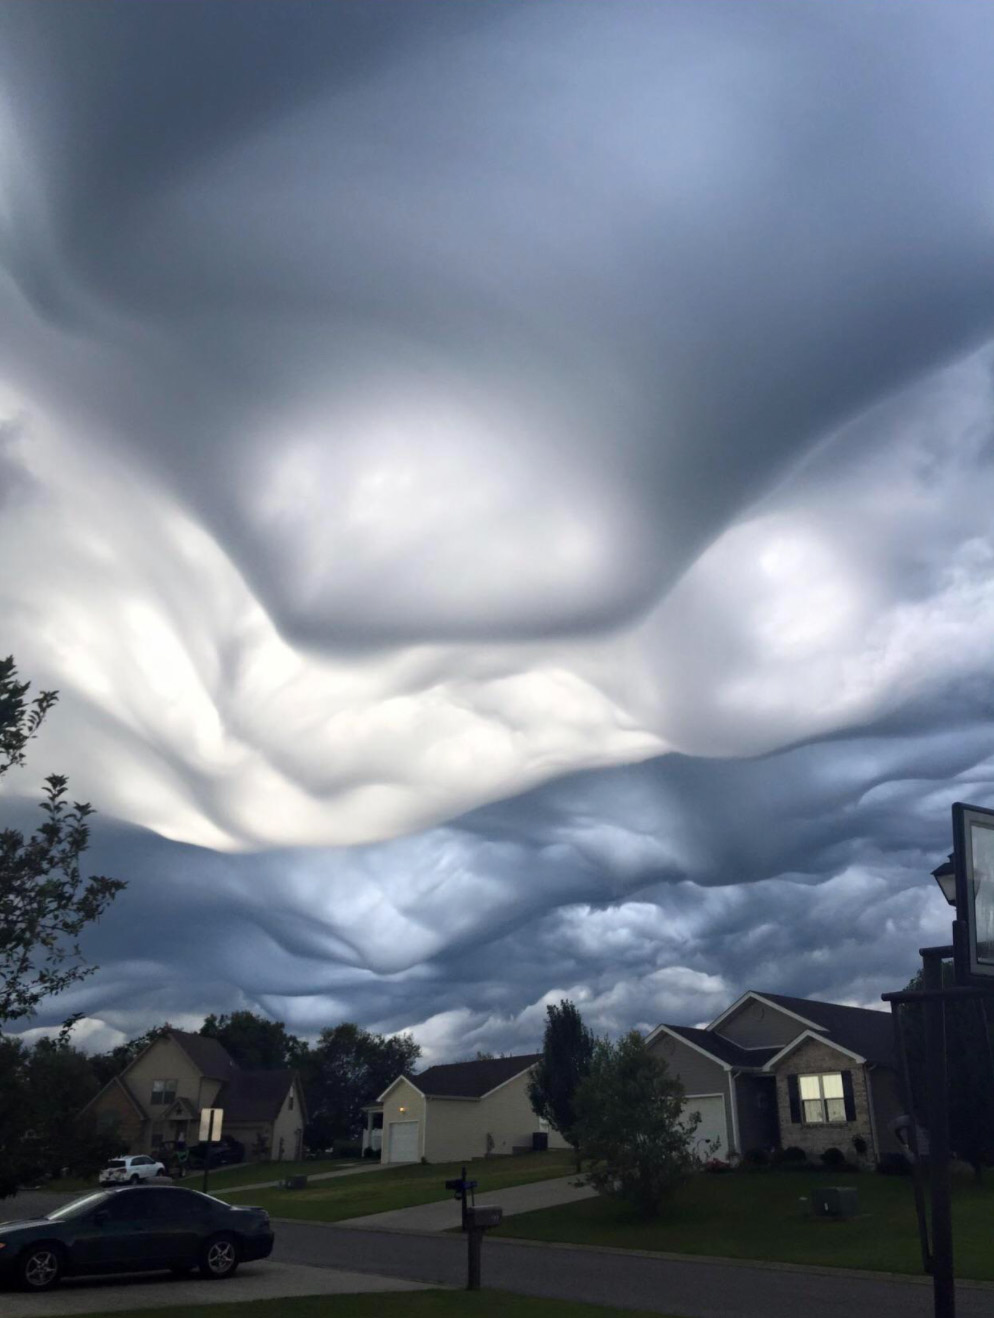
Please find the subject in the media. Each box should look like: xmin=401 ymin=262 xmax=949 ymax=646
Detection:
xmin=302 ymin=1023 xmax=421 ymax=1148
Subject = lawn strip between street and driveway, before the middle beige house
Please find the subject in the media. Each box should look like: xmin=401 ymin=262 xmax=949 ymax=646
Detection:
xmin=216 ymin=1151 xmax=573 ymax=1222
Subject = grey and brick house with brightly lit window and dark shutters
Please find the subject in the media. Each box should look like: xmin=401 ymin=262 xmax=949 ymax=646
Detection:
xmin=646 ymin=991 xmax=904 ymax=1160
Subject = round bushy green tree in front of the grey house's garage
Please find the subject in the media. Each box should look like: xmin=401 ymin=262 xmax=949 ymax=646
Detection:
xmin=575 ymin=1029 xmax=699 ymax=1217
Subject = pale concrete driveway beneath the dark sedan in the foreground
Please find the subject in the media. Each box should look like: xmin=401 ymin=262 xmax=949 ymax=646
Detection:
xmin=0 ymin=1261 xmax=424 ymax=1318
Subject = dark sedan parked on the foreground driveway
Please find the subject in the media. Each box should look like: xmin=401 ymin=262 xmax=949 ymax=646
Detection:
xmin=0 ymin=1185 xmax=273 ymax=1290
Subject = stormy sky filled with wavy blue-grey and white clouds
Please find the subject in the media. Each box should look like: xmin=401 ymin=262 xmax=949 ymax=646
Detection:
xmin=0 ymin=0 xmax=994 ymax=1060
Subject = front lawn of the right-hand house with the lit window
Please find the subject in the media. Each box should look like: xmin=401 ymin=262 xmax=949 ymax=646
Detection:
xmin=497 ymin=1172 xmax=994 ymax=1280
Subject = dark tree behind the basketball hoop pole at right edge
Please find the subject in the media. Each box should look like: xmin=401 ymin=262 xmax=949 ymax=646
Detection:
xmin=900 ymin=962 xmax=994 ymax=1181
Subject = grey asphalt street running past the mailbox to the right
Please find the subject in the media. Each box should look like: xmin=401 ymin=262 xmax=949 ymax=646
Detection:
xmin=274 ymin=1220 xmax=994 ymax=1318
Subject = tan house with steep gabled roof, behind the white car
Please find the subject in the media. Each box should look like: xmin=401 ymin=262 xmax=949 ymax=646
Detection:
xmin=83 ymin=1029 xmax=306 ymax=1160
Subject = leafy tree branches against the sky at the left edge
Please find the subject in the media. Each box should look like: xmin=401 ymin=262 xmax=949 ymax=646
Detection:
xmin=0 ymin=656 xmax=125 ymax=1024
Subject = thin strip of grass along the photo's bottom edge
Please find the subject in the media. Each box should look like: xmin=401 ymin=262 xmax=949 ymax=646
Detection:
xmin=73 ymin=1290 xmax=660 ymax=1318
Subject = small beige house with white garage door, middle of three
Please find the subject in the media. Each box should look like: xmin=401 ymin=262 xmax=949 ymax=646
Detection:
xmin=363 ymin=1053 xmax=567 ymax=1162
